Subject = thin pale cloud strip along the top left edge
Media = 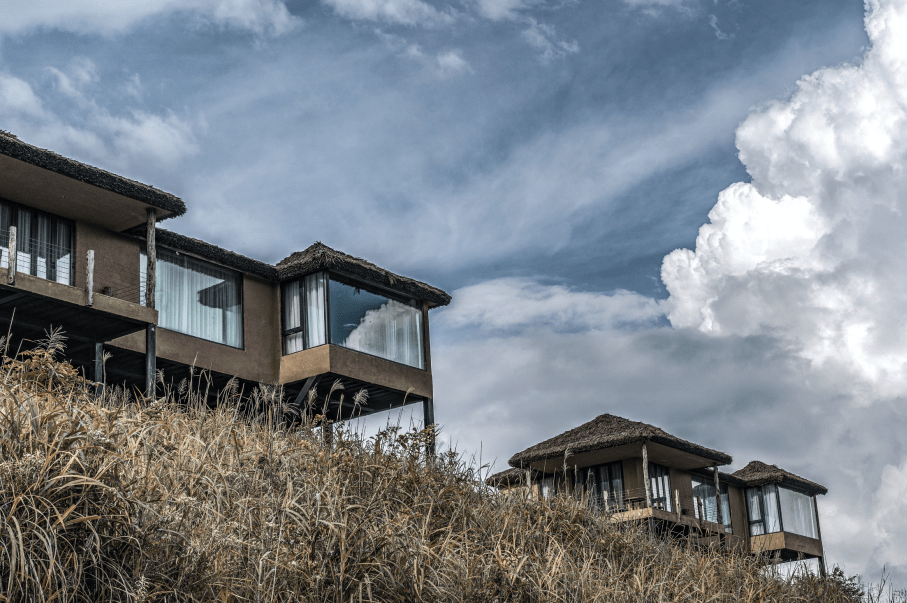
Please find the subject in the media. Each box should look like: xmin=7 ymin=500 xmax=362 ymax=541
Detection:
xmin=0 ymin=0 xmax=301 ymax=35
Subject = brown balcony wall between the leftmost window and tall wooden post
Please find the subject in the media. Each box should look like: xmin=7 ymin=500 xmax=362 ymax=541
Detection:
xmin=75 ymin=221 xmax=144 ymax=304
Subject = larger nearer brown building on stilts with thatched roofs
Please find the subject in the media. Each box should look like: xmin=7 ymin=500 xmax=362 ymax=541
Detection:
xmin=0 ymin=131 xmax=450 ymax=436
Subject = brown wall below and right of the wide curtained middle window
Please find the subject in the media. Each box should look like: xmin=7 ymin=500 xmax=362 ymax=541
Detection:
xmin=111 ymin=274 xmax=280 ymax=383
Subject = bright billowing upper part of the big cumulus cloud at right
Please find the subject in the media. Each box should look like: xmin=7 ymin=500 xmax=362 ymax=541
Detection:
xmin=662 ymin=0 xmax=907 ymax=397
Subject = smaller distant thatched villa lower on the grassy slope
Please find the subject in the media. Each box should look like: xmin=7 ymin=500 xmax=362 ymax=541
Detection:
xmin=486 ymin=414 xmax=828 ymax=572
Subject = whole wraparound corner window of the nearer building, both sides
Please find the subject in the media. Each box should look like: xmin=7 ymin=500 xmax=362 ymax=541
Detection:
xmin=283 ymin=272 xmax=425 ymax=368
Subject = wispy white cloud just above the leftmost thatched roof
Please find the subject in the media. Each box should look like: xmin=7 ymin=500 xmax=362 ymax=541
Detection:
xmin=0 ymin=58 xmax=199 ymax=172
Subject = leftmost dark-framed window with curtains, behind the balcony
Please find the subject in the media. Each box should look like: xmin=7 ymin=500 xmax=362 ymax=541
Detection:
xmin=0 ymin=201 xmax=74 ymax=285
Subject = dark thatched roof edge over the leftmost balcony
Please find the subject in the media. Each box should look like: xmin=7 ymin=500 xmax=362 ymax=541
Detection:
xmin=0 ymin=130 xmax=186 ymax=217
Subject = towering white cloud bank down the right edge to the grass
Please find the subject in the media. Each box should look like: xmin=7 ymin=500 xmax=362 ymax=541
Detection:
xmin=662 ymin=0 xmax=907 ymax=576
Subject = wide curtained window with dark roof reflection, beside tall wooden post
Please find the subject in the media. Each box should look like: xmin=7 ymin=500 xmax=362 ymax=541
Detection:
xmin=140 ymin=248 xmax=243 ymax=348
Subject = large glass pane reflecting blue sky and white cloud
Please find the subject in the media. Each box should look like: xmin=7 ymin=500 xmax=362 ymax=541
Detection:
xmin=329 ymin=280 xmax=425 ymax=368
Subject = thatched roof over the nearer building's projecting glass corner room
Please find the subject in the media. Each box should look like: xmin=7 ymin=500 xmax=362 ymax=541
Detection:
xmin=277 ymin=242 xmax=450 ymax=306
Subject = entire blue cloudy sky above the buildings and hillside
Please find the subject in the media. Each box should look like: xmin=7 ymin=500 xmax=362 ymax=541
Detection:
xmin=0 ymin=0 xmax=907 ymax=586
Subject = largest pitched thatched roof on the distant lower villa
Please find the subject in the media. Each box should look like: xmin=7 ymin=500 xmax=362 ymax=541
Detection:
xmin=509 ymin=414 xmax=733 ymax=467
